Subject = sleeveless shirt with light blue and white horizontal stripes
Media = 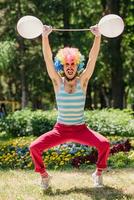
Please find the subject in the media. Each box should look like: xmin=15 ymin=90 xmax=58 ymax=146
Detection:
xmin=56 ymin=80 xmax=86 ymax=125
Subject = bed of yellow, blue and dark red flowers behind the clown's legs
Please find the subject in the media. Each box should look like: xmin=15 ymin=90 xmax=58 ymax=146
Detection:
xmin=0 ymin=137 xmax=134 ymax=169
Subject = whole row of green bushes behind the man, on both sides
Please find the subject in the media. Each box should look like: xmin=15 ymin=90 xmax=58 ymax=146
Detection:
xmin=0 ymin=109 xmax=134 ymax=137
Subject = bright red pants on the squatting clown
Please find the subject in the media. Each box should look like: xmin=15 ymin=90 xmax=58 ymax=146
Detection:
xmin=30 ymin=123 xmax=110 ymax=173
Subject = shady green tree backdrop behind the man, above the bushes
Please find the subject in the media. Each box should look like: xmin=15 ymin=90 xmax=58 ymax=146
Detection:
xmin=0 ymin=0 xmax=134 ymax=109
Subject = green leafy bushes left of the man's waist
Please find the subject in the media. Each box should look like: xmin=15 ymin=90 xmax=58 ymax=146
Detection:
xmin=1 ymin=109 xmax=56 ymax=137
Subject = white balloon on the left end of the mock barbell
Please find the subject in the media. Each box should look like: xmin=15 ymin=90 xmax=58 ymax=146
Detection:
xmin=17 ymin=15 xmax=43 ymax=39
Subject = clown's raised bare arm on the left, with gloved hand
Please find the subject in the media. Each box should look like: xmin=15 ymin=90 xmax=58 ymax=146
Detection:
xmin=42 ymin=25 xmax=60 ymax=84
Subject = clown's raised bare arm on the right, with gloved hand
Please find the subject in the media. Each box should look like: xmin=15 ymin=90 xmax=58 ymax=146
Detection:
xmin=80 ymin=25 xmax=101 ymax=85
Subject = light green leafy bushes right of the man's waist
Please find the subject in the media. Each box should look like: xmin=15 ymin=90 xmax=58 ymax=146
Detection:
xmin=85 ymin=109 xmax=134 ymax=137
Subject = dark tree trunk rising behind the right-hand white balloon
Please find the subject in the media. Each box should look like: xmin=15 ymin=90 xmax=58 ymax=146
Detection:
xmin=106 ymin=0 xmax=124 ymax=109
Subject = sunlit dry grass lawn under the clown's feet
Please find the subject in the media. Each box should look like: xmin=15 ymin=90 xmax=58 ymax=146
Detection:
xmin=0 ymin=169 xmax=134 ymax=200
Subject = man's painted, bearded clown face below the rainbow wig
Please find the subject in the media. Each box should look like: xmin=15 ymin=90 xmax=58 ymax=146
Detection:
xmin=63 ymin=55 xmax=77 ymax=80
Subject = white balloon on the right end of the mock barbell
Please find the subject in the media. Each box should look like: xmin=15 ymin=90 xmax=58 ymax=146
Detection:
xmin=98 ymin=14 xmax=124 ymax=38
